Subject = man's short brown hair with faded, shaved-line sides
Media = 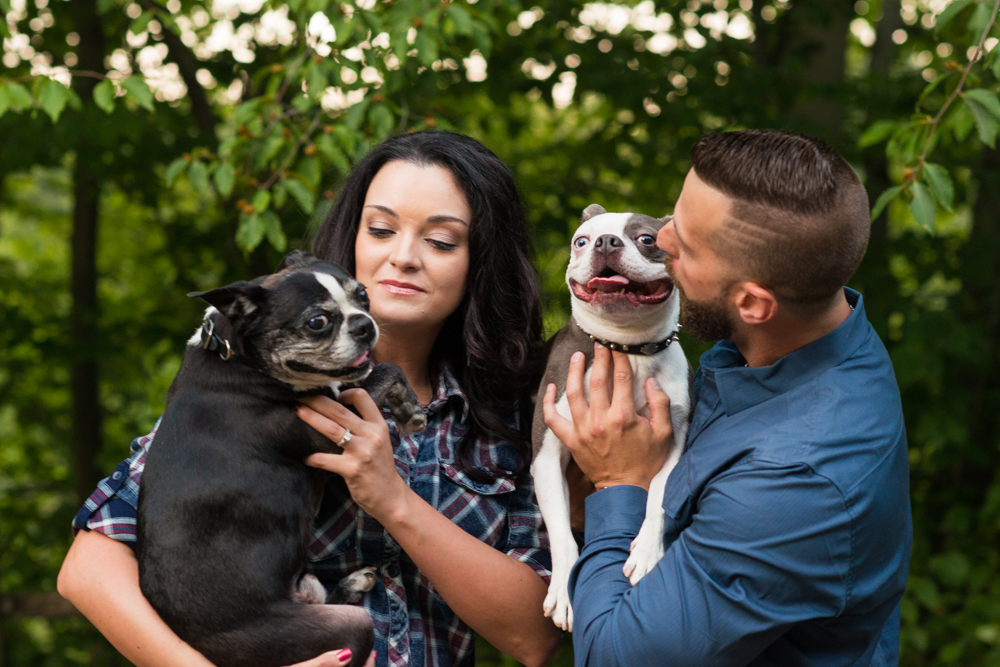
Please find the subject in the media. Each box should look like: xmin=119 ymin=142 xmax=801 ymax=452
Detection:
xmin=691 ymin=130 xmax=870 ymax=314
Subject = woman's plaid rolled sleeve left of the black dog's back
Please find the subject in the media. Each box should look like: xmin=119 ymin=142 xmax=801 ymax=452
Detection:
xmin=73 ymin=421 xmax=159 ymax=548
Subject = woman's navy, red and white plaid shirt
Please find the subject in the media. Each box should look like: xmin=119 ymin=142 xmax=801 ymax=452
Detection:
xmin=73 ymin=369 xmax=550 ymax=667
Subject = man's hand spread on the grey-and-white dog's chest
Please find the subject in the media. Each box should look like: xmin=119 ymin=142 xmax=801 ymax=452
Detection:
xmin=542 ymin=345 xmax=673 ymax=490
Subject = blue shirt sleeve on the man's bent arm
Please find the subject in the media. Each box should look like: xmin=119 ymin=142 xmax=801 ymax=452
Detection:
xmin=569 ymin=466 xmax=851 ymax=667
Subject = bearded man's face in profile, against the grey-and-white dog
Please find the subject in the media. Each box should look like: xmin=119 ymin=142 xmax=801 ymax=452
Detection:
xmin=656 ymin=169 xmax=735 ymax=340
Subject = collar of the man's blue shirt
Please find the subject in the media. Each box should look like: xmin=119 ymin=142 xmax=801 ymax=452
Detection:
xmin=700 ymin=287 xmax=871 ymax=415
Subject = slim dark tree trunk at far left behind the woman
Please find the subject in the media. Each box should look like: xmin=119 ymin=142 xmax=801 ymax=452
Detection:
xmin=70 ymin=0 xmax=105 ymax=499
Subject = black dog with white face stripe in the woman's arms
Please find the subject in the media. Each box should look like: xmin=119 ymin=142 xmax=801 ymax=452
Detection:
xmin=137 ymin=252 xmax=426 ymax=667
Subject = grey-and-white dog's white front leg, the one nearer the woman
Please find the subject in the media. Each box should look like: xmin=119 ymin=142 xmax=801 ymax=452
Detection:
xmin=531 ymin=430 xmax=580 ymax=631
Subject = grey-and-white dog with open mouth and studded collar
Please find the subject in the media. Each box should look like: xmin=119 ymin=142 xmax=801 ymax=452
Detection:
xmin=531 ymin=204 xmax=691 ymax=630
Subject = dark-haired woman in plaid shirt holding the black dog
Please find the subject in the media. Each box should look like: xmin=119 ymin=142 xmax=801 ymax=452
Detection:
xmin=59 ymin=133 xmax=559 ymax=667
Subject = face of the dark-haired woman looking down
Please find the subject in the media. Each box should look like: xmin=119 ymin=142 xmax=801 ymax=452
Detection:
xmin=354 ymin=161 xmax=472 ymax=335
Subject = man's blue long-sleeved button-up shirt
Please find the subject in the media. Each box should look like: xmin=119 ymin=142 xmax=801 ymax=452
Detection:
xmin=570 ymin=290 xmax=912 ymax=667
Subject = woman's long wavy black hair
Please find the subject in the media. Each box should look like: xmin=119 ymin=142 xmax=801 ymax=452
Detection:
xmin=312 ymin=132 xmax=542 ymax=480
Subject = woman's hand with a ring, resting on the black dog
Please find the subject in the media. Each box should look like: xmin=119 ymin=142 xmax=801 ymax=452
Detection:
xmin=296 ymin=389 xmax=409 ymax=525
